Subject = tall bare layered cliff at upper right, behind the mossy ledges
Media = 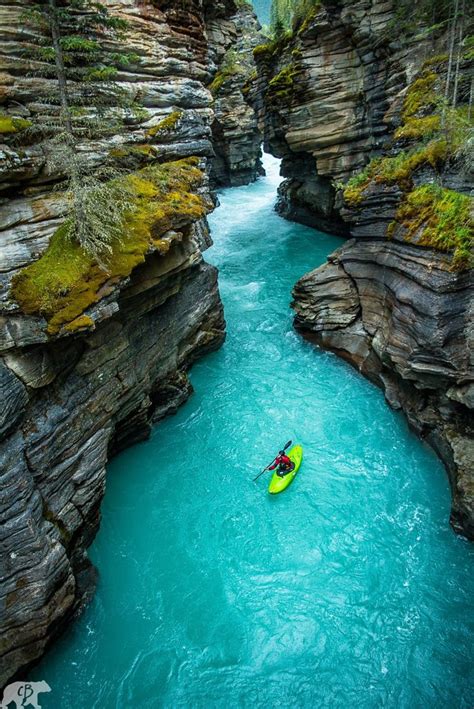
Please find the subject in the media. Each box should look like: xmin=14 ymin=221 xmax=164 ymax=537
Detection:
xmin=256 ymin=0 xmax=425 ymax=235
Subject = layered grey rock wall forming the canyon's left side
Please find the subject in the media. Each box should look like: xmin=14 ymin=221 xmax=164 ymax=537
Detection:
xmin=0 ymin=0 xmax=253 ymax=684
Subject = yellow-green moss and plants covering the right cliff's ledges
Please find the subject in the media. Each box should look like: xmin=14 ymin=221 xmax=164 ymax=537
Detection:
xmin=344 ymin=42 xmax=474 ymax=268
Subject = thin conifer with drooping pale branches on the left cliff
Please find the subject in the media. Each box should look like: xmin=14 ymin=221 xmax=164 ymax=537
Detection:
xmin=25 ymin=0 xmax=141 ymax=268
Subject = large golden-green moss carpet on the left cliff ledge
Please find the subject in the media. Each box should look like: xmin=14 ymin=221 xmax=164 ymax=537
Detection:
xmin=11 ymin=158 xmax=209 ymax=335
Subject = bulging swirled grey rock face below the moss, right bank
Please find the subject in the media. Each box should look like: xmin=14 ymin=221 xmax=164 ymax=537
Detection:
xmin=293 ymin=216 xmax=474 ymax=539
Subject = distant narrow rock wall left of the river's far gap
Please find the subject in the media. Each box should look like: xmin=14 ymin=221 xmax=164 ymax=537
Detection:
xmin=208 ymin=4 xmax=263 ymax=187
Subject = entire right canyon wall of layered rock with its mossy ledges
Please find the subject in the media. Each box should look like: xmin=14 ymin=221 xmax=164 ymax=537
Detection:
xmin=255 ymin=0 xmax=474 ymax=539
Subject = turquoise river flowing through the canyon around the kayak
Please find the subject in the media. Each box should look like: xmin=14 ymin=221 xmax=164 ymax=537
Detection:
xmin=31 ymin=159 xmax=474 ymax=709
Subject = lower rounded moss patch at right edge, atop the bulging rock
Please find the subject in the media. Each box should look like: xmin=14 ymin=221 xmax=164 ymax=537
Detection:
xmin=391 ymin=184 xmax=474 ymax=269
